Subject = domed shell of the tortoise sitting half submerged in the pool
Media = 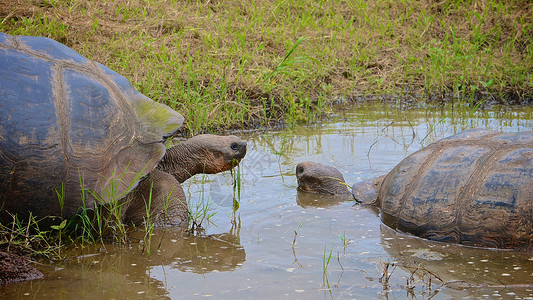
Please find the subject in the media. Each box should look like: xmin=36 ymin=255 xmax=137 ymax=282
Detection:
xmin=377 ymin=130 xmax=533 ymax=250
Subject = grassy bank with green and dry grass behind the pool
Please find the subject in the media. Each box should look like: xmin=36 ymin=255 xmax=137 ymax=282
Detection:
xmin=0 ymin=0 xmax=533 ymax=132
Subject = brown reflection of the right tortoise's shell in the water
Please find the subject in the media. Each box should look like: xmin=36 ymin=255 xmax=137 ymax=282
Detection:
xmin=380 ymin=225 xmax=533 ymax=298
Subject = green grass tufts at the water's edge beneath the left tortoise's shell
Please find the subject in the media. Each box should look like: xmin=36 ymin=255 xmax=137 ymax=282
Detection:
xmin=0 ymin=169 xmax=158 ymax=259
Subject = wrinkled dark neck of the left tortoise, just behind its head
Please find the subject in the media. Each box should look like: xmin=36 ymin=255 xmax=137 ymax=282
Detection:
xmin=157 ymin=142 xmax=202 ymax=183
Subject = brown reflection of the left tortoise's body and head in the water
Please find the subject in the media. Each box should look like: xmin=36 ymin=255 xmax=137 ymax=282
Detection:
xmin=0 ymin=230 xmax=246 ymax=299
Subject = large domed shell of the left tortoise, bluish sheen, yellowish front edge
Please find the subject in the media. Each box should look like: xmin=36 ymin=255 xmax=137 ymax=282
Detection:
xmin=0 ymin=33 xmax=183 ymax=218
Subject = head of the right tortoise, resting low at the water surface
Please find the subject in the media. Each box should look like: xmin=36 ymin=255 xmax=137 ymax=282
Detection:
xmin=296 ymin=161 xmax=350 ymax=195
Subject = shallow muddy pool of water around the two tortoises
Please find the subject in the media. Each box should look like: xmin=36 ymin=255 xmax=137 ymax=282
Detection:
xmin=0 ymin=108 xmax=533 ymax=299
